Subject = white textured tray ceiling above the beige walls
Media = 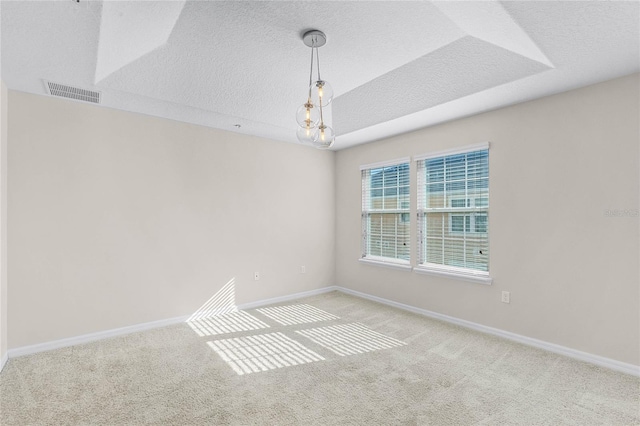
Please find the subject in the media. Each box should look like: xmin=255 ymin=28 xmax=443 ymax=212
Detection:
xmin=0 ymin=0 xmax=640 ymax=149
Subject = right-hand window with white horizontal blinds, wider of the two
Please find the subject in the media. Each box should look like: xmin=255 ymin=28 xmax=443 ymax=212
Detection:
xmin=417 ymin=148 xmax=489 ymax=275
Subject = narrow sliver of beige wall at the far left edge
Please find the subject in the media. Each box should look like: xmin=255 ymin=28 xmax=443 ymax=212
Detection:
xmin=0 ymin=81 xmax=8 ymax=360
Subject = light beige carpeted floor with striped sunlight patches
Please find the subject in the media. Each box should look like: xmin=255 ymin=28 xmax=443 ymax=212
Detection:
xmin=0 ymin=292 xmax=640 ymax=425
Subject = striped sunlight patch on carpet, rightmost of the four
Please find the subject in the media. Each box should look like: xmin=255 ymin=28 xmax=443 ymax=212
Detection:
xmin=296 ymin=323 xmax=406 ymax=356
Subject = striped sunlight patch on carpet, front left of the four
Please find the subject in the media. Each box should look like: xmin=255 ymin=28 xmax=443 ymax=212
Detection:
xmin=207 ymin=333 xmax=324 ymax=375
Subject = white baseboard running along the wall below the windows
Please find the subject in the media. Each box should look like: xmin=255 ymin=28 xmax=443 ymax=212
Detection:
xmin=335 ymin=286 xmax=640 ymax=377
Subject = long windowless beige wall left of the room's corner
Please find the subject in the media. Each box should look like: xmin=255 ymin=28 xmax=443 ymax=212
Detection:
xmin=8 ymin=91 xmax=335 ymax=349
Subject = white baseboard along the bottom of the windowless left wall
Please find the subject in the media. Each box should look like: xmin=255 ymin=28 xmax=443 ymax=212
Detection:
xmin=7 ymin=286 xmax=337 ymax=360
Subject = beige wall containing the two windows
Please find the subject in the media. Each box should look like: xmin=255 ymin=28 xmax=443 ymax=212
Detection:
xmin=336 ymin=74 xmax=640 ymax=365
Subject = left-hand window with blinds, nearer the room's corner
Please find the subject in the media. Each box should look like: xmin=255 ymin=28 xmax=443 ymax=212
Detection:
xmin=361 ymin=159 xmax=410 ymax=266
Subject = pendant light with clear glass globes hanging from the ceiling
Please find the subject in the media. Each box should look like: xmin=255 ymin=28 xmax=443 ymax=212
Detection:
xmin=296 ymin=30 xmax=336 ymax=149
